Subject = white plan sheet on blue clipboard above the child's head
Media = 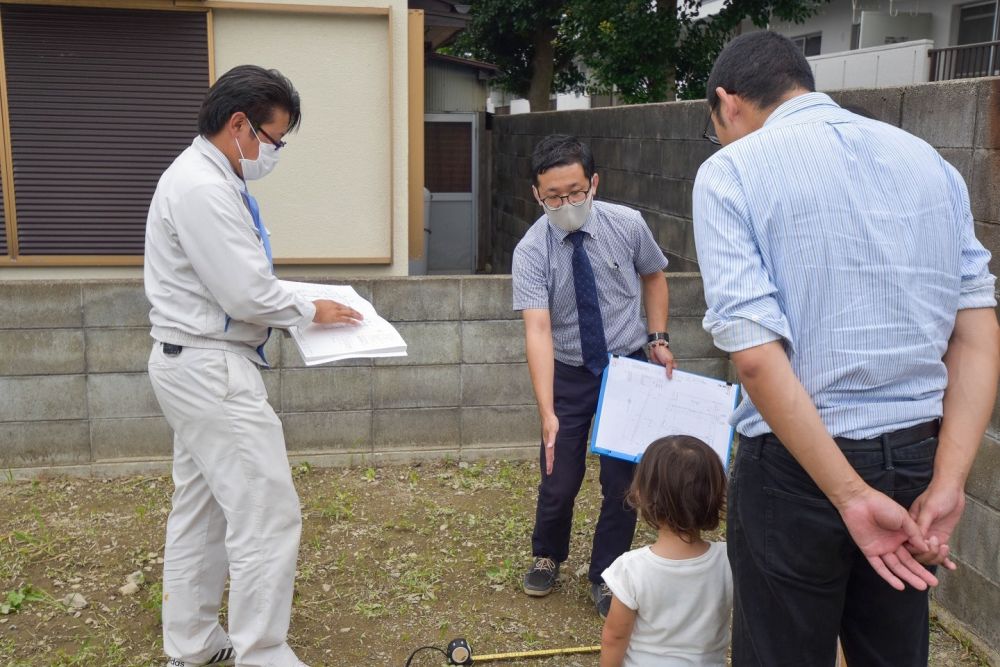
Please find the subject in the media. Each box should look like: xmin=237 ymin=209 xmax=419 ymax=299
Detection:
xmin=590 ymin=357 xmax=740 ymax=468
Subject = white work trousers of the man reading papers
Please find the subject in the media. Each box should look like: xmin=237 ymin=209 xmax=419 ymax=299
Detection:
xmin=149 ymin=343 xmax=302 ymax=667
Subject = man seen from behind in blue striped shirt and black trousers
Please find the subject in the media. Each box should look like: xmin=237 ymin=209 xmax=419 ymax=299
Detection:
xmin=694 ymin=32 xmax=1000 ymax=667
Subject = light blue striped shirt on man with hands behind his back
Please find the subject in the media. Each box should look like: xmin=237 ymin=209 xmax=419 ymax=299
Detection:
xmin=694 ymin=93 xmax=996 ymax=438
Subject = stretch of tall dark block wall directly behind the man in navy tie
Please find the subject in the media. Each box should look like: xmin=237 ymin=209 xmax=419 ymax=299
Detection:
xmin=491 ymin=102 xmax=716 ymax=273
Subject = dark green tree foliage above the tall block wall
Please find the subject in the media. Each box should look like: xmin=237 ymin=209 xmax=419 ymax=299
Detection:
xmin=456 ymin=0 xmax=829 ymax=109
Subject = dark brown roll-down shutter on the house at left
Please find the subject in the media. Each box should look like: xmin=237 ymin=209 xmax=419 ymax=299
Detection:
xmin=0 ymin=5 xmax=208 ymax=255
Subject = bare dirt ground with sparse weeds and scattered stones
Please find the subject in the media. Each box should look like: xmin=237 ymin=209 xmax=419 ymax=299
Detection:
xmin=0 ymin=462 xmax=987 ymax=667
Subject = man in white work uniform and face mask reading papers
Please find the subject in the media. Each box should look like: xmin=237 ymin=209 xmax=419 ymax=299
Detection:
xmin=144 ymin=65 xmax=361 ymax=667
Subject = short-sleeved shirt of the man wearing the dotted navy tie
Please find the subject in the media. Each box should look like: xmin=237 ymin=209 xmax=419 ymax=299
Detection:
xmin=511 ymin=201 xmax=667 ymax=366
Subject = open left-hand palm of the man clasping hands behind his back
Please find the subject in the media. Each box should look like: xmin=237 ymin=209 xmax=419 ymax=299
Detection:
xmin=837 ymin=486 xmax=938 ymax=591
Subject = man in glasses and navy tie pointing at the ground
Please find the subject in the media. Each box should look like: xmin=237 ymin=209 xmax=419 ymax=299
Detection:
xmin=512 ymin=135 xmax=674 ymax=617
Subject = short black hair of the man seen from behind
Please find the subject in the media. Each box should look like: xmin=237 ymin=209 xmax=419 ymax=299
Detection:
xmin=706 ymin=30 xmax=816 ymax=111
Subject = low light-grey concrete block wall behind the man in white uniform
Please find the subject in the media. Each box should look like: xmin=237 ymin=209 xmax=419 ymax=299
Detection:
xmin=0 ymin=274 xmax=728 ymax=477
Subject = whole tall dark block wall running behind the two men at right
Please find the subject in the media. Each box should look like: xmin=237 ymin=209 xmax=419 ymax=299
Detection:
xmin=491 ymin=78 xmax=1000 ymax=664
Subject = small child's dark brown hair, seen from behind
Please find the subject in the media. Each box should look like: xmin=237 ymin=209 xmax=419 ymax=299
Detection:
xmin=628 ymin=435 xmax=726 ymax=542
